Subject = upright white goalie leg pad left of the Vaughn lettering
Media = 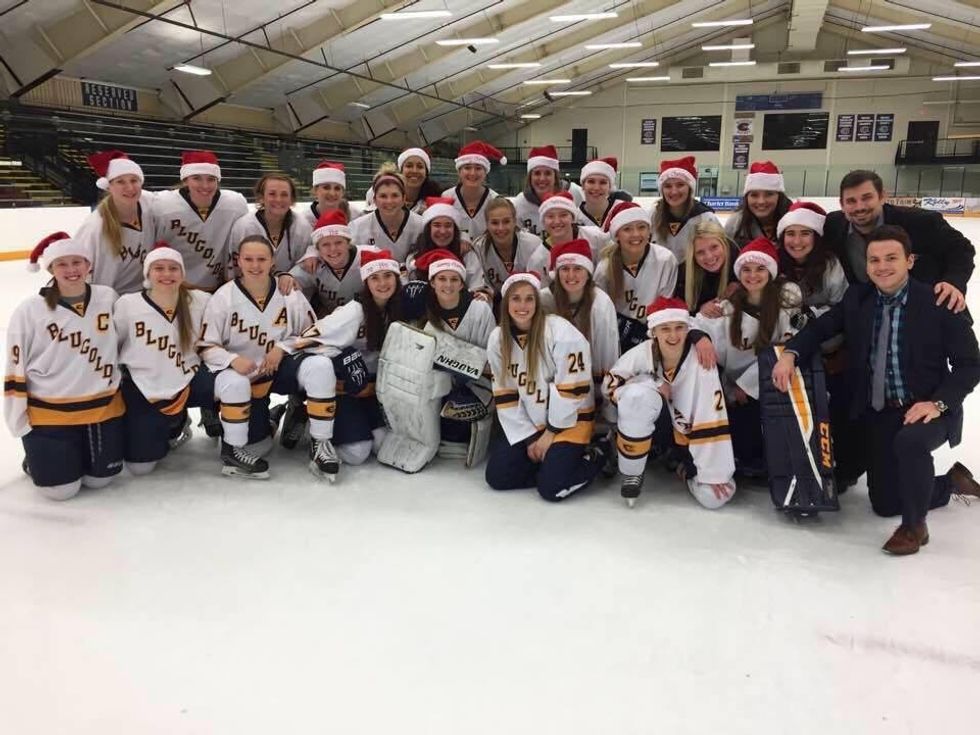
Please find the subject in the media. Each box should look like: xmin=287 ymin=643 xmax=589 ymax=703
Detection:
xmin=375 ymin=322 xmax=452 ymax=472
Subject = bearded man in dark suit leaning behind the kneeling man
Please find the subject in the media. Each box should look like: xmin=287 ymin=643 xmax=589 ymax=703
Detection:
xmin=823 ymin=171 xmax=976 ymax=312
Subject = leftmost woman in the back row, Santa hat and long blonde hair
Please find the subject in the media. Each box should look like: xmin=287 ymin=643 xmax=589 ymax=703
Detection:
xmin=73 ymin=151 xmax=154 ymax=294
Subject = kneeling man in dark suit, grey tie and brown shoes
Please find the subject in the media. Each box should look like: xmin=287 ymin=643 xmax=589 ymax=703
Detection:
xmin=772 ymin=225 xmax=980 ymax=555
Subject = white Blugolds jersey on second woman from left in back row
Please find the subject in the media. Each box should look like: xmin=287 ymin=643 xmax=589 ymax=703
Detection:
xmin=152 ymin=189 xmax=248 ymax=291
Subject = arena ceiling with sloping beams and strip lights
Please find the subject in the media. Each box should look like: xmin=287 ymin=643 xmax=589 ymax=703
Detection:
xmin=0 ymin=0 xmax=980 ymax=144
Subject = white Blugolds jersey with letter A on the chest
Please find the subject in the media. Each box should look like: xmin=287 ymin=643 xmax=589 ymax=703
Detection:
xmin=201 ymin=278 xmax=316 ymax=397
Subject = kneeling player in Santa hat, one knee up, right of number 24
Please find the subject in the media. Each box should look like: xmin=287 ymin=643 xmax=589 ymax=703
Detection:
xmin=605 ymin=297 xmax=735 ymax=509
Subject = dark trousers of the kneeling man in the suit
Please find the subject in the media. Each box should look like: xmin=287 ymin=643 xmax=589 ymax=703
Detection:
xmin=865 ymin=408 xmax=949 ymax=525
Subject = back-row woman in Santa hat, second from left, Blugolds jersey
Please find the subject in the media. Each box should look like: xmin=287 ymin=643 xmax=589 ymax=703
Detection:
xmin=153 ymin=151 xmax=248 ymax=292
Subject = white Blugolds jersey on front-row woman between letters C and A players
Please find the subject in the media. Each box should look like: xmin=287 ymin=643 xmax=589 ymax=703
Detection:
xmin=112 ymin=291 xmax=210 ymax=415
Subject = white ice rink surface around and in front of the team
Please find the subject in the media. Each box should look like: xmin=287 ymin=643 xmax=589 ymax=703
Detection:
xmin=0 ymin=219 xmax=980 ymax=735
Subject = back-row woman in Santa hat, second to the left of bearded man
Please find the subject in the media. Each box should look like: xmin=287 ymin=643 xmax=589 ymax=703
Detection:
xmin=653 ymin=156 xmax=721 ymax=261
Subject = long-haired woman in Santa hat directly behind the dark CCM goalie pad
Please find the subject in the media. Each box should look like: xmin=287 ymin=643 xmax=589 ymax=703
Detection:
xmin=696 ymin=237 xmax=803 ymax=475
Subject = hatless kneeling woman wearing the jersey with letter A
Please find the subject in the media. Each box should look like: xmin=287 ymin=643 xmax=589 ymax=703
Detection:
xmin=201 ymin=235 xmax=337 ymax=479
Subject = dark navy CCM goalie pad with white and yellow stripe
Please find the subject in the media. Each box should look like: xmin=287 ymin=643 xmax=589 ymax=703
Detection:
xmin=758 ymin=346 xmax=840 ymax=516
